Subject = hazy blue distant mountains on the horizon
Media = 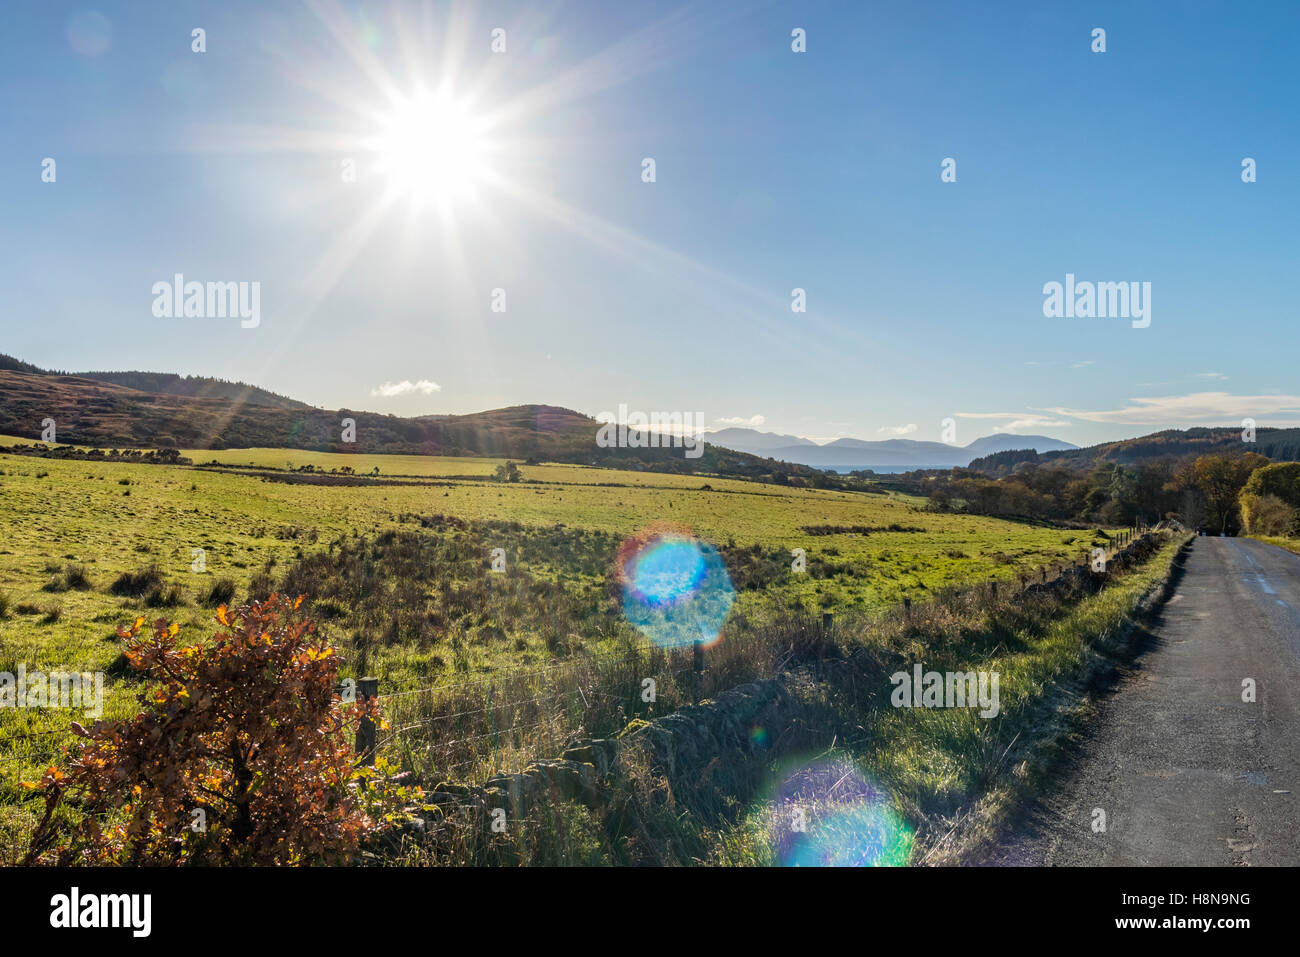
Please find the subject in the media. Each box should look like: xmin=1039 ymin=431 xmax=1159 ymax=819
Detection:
xmin=705 ymin=429 xmax=1079 ymax=468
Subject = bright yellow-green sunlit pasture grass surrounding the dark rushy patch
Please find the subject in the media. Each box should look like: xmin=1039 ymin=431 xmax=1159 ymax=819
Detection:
xmin=0 ymin=450 xmax=1128 ymax=863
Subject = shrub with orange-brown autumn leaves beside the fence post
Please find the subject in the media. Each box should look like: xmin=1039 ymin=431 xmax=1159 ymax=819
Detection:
xmin=26 ymin=596 xmax=378 ymax=865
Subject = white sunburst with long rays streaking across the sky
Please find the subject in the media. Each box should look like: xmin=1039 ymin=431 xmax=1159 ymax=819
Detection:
xmin=149 ymin=0 xmax=881 ymax=403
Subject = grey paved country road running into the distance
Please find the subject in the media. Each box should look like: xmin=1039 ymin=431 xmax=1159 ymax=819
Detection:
xmin=988 ymin=537 xmax=1300 ymax=866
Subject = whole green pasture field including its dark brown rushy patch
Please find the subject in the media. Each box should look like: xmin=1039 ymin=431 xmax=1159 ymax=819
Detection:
xmin=0 ymin=450 xmax=1118 ymax=848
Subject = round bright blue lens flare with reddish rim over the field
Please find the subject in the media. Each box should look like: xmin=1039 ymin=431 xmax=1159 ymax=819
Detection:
xmin=619 ymin=525 xmax=736 ymax=648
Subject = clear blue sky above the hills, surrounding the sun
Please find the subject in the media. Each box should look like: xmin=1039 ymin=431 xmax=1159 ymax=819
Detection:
xmin=0 ymin=0 xmax=1300 ymax=445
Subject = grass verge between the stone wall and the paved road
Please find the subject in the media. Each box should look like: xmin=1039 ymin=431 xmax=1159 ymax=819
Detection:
xmin=709 ymin=536 xmax=1191 ymax=866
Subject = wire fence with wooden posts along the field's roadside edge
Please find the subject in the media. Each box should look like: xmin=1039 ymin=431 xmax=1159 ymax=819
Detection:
xmin=0 ymin=527 xmax=1145 ymax=780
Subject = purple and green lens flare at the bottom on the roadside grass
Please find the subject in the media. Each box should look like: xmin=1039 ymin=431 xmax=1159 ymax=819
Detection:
xmin=774 ymin=759 xmax=915 ymax=867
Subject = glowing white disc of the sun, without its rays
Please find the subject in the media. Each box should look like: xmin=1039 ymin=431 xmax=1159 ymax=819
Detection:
xmin=368 ymin=88 xmax=491 ymax=208
